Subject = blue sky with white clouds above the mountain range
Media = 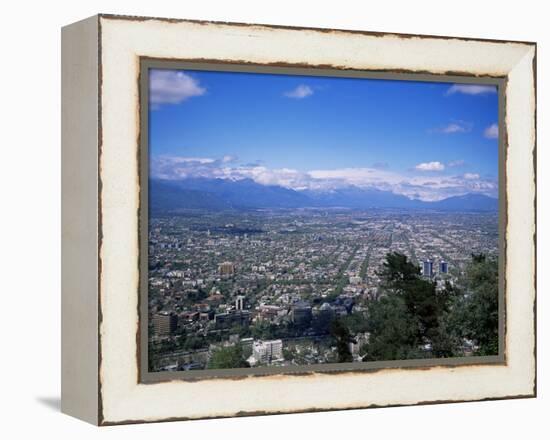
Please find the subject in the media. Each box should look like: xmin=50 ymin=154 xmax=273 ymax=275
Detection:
xmin=149 ymin=70 xmax=498 ymax=200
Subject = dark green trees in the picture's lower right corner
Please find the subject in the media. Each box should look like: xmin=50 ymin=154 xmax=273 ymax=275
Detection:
xmin=364 ymin=253 xmax=498 ymax=361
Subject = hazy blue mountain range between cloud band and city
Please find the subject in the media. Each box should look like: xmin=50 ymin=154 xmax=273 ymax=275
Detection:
xmin=149 ymin=178 xmax=498 ymax=212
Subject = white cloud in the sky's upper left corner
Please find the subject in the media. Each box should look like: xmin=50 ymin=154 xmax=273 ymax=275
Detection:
xmin=149 ymin=70 xmax=206 ymax=107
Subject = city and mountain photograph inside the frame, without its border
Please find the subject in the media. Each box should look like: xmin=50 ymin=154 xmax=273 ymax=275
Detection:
xmin=147 ymin=69 xmax=499 ymax=372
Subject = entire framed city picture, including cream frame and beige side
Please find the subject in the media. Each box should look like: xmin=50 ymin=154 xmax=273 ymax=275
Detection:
xmin=62 ymin=15 xmax=536 ymax=425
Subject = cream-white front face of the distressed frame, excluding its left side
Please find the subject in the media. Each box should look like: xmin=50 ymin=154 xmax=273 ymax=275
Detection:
xmin=100 ymin=19 xmax=534 ymax=422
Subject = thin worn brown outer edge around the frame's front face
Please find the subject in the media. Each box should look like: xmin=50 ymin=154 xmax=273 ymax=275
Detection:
xmin=91 ymin=14 xmax=537 ymax=426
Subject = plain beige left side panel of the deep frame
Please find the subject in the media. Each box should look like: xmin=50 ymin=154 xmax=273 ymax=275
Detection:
xmin=61 ymin=17 xmax=99 ymax=425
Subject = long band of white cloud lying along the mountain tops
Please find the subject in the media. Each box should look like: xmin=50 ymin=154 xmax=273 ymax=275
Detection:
xmin=151 ymin=156 xmax=498 ymax=201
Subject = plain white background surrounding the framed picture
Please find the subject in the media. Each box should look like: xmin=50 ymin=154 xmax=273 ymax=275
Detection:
xmin=0 ymin=0 xmax=550 ymax=440
